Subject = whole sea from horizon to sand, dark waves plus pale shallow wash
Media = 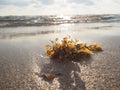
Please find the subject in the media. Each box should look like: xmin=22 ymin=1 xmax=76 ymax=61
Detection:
xmin=0 ymin=14 xmax=120 ymax=39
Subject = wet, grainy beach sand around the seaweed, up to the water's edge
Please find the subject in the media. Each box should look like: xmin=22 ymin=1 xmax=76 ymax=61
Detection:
xmin=0 ymin=30 xmax=120 ymax=90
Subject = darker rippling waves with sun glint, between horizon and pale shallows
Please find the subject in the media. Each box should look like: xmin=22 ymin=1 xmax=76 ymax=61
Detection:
xmin=0 ymin=14 xmax=120 ymax=27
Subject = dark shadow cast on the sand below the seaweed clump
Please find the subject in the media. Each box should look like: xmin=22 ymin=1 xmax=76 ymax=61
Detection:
xmin=36 ymin=57 xmax=92 ymax=90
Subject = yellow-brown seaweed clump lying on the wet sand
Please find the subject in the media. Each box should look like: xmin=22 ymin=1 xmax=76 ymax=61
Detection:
xmin=45 ymin=36 xmax=102 ymax=61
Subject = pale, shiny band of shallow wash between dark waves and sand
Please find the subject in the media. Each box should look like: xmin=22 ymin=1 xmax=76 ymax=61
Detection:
xmin=0 ymin=23 xmax=120 ymax=39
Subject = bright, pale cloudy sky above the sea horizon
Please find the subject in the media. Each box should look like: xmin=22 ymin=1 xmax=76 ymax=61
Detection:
xmin=0 ymin=0 xmax=120 ymax=16
